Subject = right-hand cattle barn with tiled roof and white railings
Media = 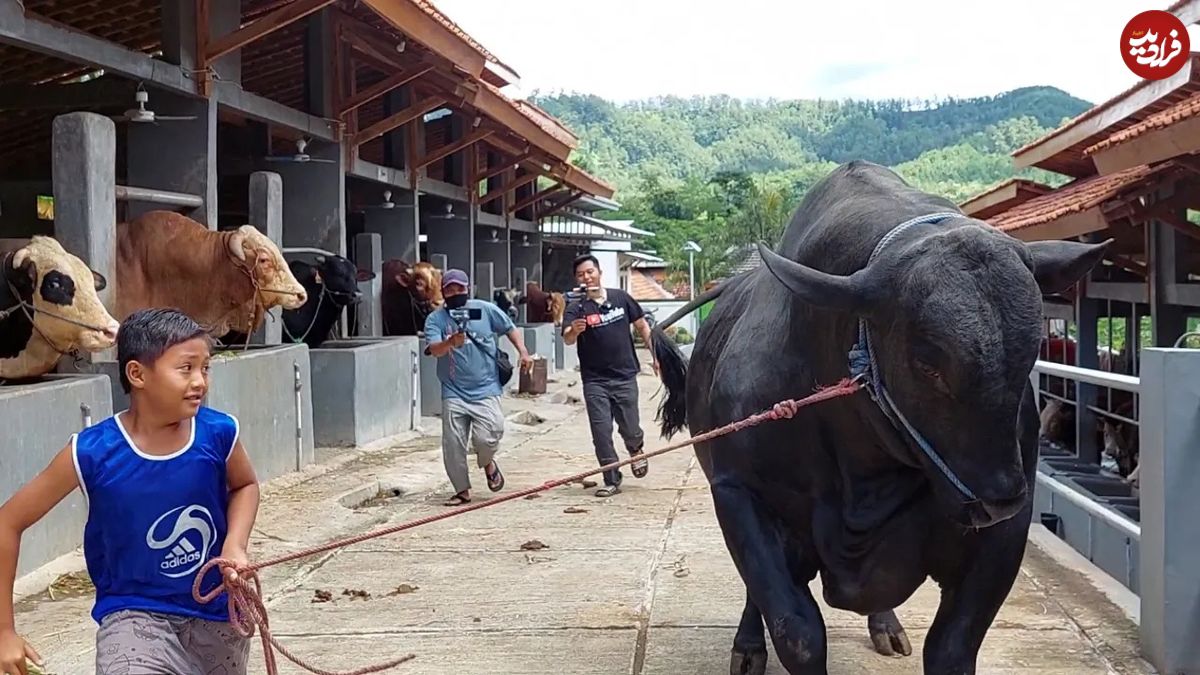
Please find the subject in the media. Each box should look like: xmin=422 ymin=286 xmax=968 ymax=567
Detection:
xmin=960 ymin=5 xmax=1200 ymax=673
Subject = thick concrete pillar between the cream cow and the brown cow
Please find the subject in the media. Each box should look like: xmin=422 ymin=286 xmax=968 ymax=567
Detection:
xmin=52 ymin=113 xmax=120 ymax=362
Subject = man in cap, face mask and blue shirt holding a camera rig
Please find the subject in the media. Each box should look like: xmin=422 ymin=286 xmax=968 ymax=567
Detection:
xmin=425 ymin=269 xmax=533 ymax=506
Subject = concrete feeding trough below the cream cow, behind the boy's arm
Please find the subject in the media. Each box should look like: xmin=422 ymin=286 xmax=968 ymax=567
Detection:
xmin=0 ymin=375 xmax=113 ymax=575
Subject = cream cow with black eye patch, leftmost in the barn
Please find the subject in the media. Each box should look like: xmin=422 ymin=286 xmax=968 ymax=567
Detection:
xmin=0 ymin=237 xmax=119 ymax=380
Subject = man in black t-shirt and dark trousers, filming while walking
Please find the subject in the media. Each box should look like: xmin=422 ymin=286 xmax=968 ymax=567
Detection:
xmin=563 ymin=255 xmax=659 ymax=497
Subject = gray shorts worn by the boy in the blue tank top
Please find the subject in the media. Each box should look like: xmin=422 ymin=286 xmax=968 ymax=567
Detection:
xmin=96 ymin=610 xmax=250 ymax=675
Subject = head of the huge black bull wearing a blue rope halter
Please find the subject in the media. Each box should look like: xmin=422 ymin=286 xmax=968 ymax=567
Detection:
xmin=760 ymin=222 xmax=1111 ymax=527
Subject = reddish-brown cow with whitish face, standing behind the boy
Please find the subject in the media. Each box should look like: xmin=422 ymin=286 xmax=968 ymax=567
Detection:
xmin=116 ymin=211 xmax=308 ymax=338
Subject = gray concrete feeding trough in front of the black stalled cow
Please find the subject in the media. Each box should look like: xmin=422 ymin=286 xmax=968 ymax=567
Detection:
xmin=308 ymin=336 xmax=422 ymax=447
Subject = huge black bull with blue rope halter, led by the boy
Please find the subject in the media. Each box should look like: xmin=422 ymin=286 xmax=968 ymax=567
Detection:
xmin=653 ymin=162 xmax=1108 ymax=675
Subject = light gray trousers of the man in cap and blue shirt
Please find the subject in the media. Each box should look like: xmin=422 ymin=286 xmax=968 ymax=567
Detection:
xmin=442 ymin=396 xmax=504 ymax=494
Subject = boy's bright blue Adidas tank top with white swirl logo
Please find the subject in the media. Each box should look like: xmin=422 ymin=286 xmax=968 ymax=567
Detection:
xmin=72 ymin=406 xmax=238 ymax=623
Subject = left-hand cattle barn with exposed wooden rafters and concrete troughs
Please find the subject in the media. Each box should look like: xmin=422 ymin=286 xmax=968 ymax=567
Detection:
xmin=0 ymin=0 xmax=614 ymax=573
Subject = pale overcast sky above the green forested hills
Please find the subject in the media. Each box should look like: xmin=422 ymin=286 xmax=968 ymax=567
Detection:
xmin=436 ymin=0 xmax=1200 ymax=103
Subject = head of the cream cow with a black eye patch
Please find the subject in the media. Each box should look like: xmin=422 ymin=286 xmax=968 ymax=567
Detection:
xmin=2 ymin=237 xmax=119 ymax=352
